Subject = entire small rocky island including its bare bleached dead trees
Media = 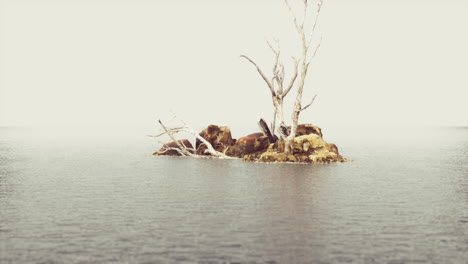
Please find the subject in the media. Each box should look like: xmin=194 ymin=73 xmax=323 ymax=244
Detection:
xmin=154 ymin=0 xmax=346 ymax=163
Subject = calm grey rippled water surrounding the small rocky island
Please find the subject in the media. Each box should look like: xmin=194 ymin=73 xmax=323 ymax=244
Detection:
xmin=0 ymin=128 xmax=468 ymax=264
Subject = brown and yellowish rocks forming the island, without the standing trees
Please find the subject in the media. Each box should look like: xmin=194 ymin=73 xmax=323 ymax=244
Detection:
xmin=154 ymin=124 xmax=346 ymax=163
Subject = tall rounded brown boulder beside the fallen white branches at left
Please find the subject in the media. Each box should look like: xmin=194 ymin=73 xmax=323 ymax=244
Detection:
xmin=195 ymin=125 xmax=236 ymax=155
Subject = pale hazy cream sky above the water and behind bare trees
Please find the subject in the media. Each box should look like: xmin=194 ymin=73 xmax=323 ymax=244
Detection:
xmin=0 ymin=0 xmax=468 ymax=131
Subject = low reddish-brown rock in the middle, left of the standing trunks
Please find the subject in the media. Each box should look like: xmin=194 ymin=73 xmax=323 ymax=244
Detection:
xmin=226 ymin=133 xmax=270 ymax=158
